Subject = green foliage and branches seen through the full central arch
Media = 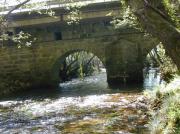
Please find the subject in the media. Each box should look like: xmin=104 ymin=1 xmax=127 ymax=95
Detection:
xmin=59 ymin=51 xmax=103 ymax=81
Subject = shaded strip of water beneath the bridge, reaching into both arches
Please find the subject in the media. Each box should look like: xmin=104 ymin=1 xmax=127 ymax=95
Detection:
xmin=1 ymin=68 xmax=164 ymax=100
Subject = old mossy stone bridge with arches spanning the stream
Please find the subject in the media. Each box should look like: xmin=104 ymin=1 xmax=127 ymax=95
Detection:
xmin=0 ymin=2 xmax=158 ymax=94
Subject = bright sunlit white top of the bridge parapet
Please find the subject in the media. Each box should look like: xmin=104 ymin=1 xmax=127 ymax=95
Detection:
xmin=0 ymin=0 xmax=119 ymax=15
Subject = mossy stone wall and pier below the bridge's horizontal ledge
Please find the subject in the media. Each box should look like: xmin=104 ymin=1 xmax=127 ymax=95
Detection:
xmin=0 ymin=34 xmax=156 ymax=94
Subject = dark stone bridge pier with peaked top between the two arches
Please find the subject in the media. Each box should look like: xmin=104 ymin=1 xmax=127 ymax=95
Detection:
xmin=105 ymin=40 xmax=143 ymax=87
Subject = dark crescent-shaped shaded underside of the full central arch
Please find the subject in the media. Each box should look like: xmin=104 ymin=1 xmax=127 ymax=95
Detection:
xmin=51 ymin=49 xmax=106 ymax=87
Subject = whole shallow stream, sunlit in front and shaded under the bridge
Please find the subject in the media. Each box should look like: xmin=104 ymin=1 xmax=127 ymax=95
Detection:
xmin=0 ymin=71 xmax=159 ymax=134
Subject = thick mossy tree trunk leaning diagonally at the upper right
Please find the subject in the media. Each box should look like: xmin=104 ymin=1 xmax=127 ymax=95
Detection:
xmin=128 ymin=0 xmax=180 ymax=70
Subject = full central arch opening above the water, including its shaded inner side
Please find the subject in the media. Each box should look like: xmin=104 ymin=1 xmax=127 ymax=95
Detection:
xmin=53 ymin=50 xmax=106 ymax=84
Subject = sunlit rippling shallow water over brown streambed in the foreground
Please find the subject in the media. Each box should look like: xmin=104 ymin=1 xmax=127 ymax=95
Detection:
xmin=0 ymin=93 xmax=148 ymax=134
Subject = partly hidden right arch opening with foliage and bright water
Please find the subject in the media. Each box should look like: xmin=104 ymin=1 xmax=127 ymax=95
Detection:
xmin=144 ymin=43 xmax=177 ymax=84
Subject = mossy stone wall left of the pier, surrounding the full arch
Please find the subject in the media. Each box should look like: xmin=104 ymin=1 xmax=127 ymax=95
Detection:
xmin=0 ymin=39 xmax=107 ymax=94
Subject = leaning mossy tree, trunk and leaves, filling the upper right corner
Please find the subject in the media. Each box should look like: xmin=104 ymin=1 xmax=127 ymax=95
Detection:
xmin=125 ymin=0 xmax=180 ymax=70
